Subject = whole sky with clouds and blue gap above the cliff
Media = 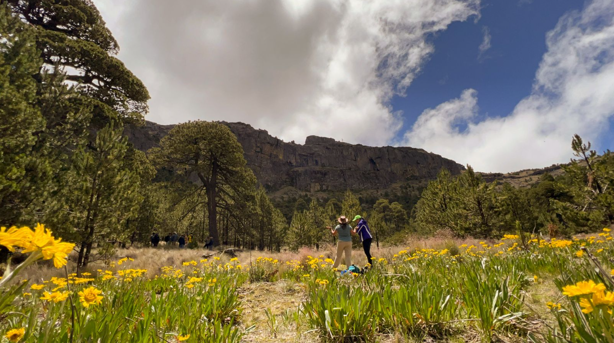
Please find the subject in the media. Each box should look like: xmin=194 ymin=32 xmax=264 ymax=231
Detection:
xmin=94 ymin=0 xmax=614 ymax=172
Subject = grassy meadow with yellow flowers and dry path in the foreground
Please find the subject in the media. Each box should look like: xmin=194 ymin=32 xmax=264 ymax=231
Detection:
xmin=0 ymin=227 xmax=614 ymax=343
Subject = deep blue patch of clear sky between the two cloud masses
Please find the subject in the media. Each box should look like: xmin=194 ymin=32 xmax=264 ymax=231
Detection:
xmin=391 ymin=0 xmax=588 ymax=139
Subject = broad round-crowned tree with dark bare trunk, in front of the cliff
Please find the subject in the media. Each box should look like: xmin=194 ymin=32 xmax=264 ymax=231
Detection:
xmin=149 ymin=121 xmax=287 ymax=250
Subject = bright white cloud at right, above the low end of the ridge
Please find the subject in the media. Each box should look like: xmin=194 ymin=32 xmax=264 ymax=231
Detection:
xmin=404 ymin=0 xmax=614 ymax=172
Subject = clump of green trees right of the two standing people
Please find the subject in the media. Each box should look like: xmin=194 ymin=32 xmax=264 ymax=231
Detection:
xmin=415 ymin=140 xmax=614 ymax=237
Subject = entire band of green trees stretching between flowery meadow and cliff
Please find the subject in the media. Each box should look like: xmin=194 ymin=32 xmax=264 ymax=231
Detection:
xmin=0 ymin=0 xmax=614 ymax=266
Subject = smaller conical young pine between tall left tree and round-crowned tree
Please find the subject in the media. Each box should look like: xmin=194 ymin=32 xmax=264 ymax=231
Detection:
xmin=47 ymin=126 xmax=147 ymax=265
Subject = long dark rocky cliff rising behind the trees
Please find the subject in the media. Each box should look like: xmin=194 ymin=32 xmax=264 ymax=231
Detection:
xmin=126 ymin=122 xmax=463 ymax=192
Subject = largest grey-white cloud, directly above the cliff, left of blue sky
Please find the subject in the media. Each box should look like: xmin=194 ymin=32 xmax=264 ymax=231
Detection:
xmin=94 ymin=0 xmax=480 ymax=145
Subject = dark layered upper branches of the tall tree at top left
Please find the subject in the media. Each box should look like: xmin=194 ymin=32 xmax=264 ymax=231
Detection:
xmin=3 ymin=0 xmax=149 ymax=122
